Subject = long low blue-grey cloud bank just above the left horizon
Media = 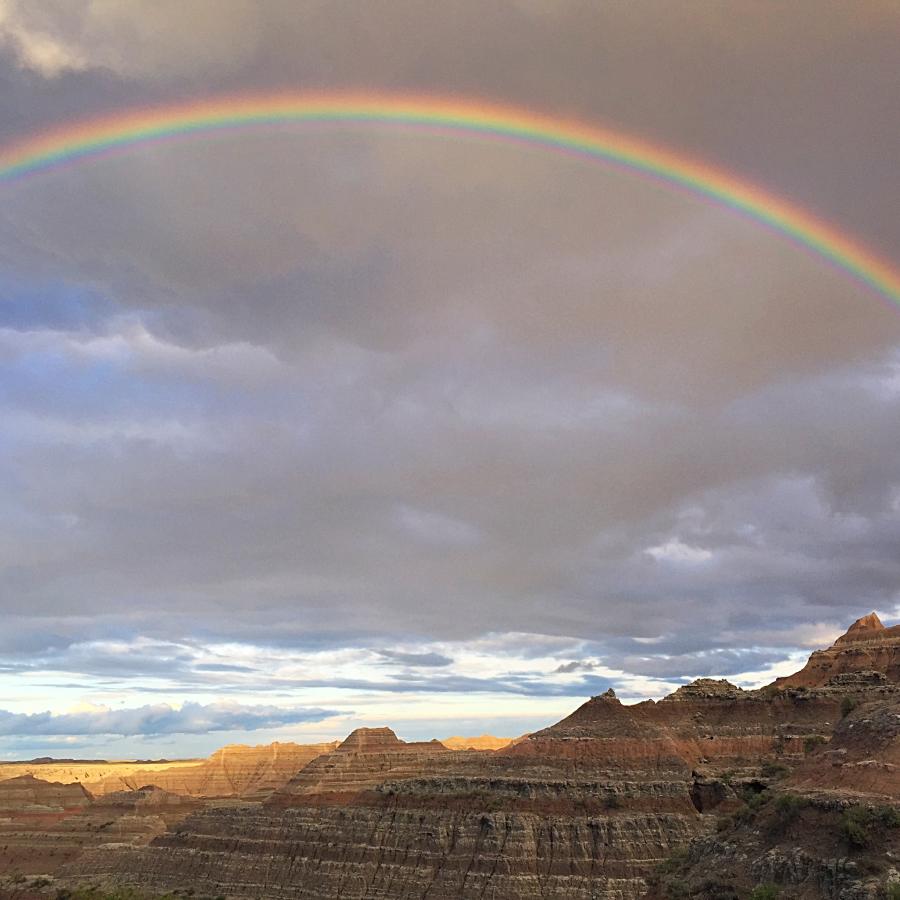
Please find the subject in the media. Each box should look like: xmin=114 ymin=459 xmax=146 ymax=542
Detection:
xmin=0 ymin=702 xmax=337 ymax=735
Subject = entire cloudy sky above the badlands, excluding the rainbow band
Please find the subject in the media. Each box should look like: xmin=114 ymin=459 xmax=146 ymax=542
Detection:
xmin=0 ymin=0 xmax=900 ymax=759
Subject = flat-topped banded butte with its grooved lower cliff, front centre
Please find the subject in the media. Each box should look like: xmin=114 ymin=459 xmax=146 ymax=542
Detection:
xmin=73 ymin=729 xmax=703 ymax=900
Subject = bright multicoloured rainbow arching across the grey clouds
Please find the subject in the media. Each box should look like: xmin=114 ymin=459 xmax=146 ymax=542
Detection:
xmin=0 ymin=93 xmax=900 ymax=305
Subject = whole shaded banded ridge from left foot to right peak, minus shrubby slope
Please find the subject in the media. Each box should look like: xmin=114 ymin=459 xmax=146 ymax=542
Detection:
xmin=59 ymin=617 xmax=900 ymax=900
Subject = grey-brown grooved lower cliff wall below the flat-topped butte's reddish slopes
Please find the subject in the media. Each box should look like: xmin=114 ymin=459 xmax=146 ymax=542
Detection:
xmin=72 ymin=806 xmax=696 ymax=900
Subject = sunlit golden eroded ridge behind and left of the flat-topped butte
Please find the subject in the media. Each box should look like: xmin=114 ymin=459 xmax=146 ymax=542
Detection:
xmin=85 ymin=741 xmax=337 ymax=799
